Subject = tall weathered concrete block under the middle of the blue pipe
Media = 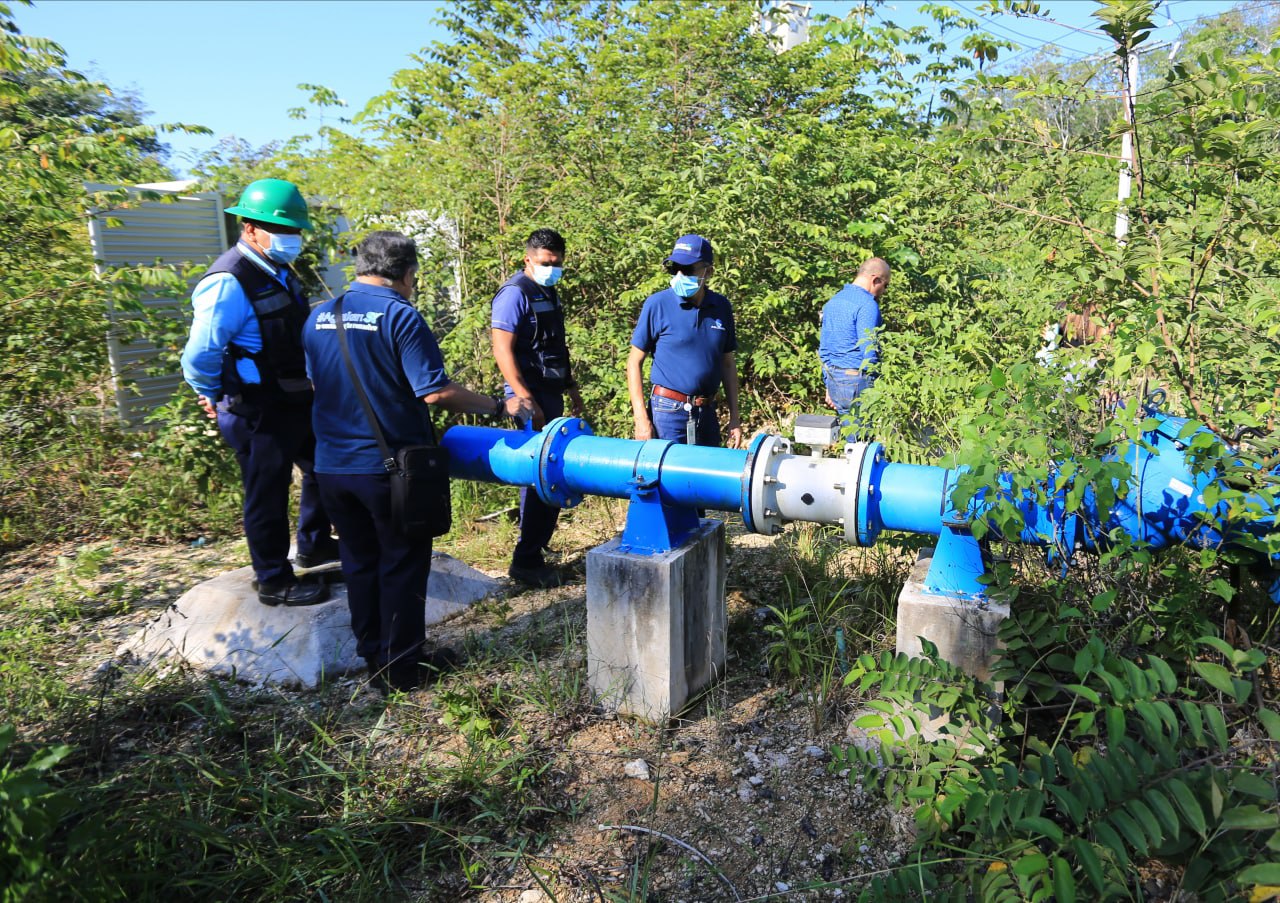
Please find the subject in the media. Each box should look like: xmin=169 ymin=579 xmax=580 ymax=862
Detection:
xmin=586 ymin=519 xmax=727 ymax=722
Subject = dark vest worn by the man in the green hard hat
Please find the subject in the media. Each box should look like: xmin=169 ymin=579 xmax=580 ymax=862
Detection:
xmin=205 ymin=247 xmax=311 ymax=405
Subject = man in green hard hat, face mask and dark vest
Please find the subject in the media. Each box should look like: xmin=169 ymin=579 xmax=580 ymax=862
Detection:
xmin=182 ymin=179 xmax=338 ymax=606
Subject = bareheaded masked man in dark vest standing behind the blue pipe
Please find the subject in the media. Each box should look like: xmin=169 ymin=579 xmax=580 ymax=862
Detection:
xmin=490 ymin=229 xmax=582 ymax=588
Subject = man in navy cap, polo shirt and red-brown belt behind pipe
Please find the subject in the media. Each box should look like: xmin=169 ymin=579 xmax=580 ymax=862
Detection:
xmin=627 ymin=234 xmax=742 ymax=448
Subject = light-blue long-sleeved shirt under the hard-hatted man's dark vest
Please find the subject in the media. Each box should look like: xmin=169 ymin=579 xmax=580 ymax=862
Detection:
xmin=182 ymin=242 xmax=288 ymax=401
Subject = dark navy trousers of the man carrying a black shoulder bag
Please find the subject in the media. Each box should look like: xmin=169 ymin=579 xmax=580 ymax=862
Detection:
xmin=317 ymin=474 xmax=431 ymax=671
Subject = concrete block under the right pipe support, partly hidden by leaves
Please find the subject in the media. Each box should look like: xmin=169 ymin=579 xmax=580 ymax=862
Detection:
xmin=897 ymin=549 xmax=1009 ymax=692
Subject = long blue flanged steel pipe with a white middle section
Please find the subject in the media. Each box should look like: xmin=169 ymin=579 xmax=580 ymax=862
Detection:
xmin=443 ymin=406 xmax=1280 ymax=593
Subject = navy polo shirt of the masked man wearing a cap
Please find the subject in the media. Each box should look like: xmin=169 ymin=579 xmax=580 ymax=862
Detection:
xmin=631 ymin=288 xmax=737 ymax=396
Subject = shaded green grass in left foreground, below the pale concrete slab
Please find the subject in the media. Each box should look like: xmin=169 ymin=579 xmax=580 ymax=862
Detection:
xmin=0 ymin=537 xmax=585 ymax=900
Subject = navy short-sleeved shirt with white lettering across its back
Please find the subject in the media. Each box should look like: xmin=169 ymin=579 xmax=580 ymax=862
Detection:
xmin=302 ymin=282 xmax=449 ymax=474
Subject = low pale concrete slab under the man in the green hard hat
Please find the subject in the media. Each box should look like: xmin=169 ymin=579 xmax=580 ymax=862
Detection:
xmin=116 ymin=552 xmax=500 ymax=688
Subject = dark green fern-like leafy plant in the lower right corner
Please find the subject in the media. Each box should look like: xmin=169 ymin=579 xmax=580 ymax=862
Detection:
xmin=832 ymin=640 xmax=1280 ymax=900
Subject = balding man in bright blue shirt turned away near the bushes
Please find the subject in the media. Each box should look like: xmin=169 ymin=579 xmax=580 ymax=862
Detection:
xmin=818 ymin=257 xmax=890 ymax=416
